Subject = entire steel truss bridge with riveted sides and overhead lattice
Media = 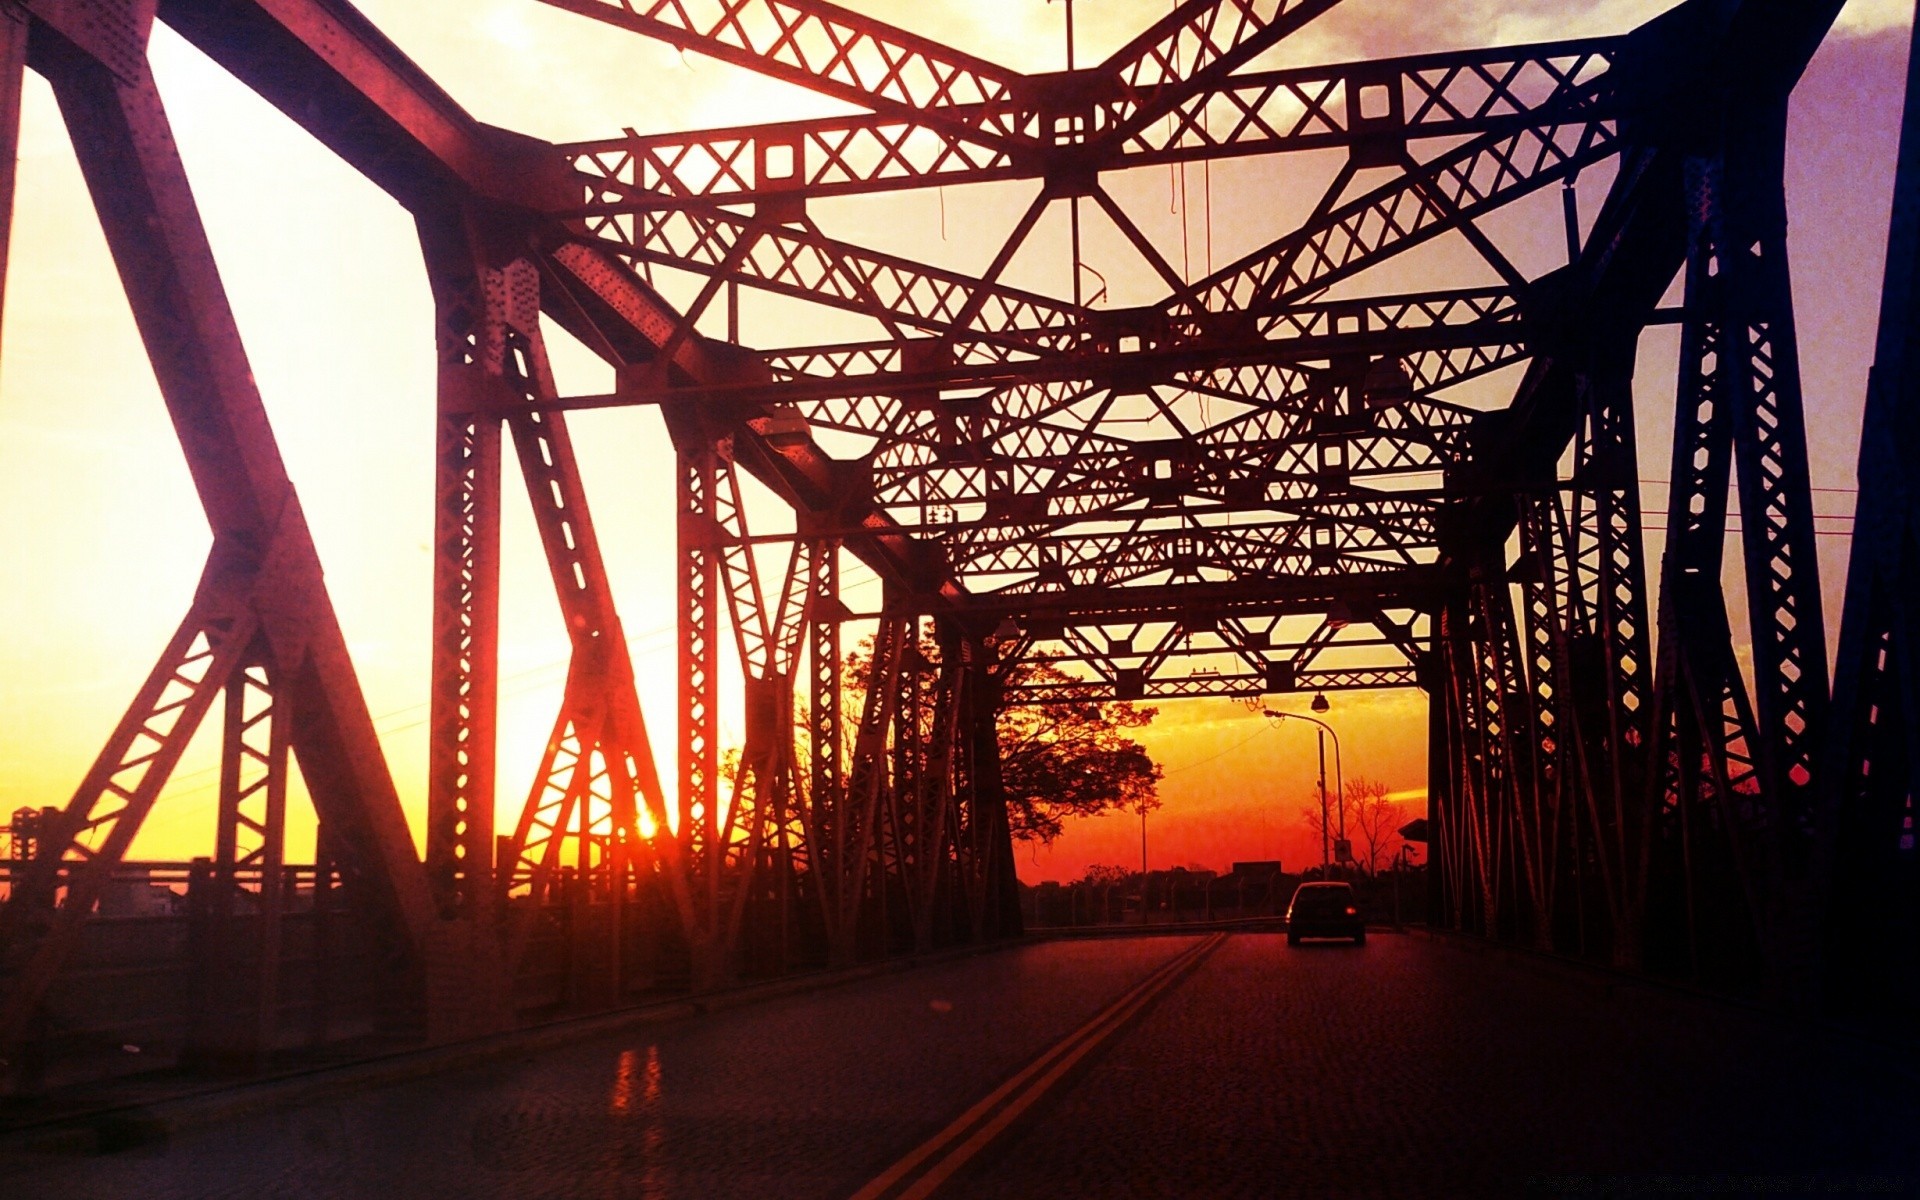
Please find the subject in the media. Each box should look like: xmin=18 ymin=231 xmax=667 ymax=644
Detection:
xmin=0 ymin=0 xmax=1920 ymax=1089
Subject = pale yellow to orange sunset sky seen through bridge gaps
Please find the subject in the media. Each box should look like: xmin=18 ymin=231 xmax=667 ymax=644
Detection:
xmin=0 ymin=0 xmax=1910 ymax=879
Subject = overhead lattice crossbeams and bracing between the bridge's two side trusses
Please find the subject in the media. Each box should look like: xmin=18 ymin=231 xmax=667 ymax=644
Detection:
xmin=541 ymin=4 xmax=1651 ymax=702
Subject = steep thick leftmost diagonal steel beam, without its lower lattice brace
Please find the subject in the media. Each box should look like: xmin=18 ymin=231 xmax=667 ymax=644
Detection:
xmin=33 ymin=4 xmax=430 ymax=937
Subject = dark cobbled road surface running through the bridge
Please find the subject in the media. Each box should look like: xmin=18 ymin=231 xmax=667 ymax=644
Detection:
xmin=0 ymin=933 xmax=1920 ymax=1200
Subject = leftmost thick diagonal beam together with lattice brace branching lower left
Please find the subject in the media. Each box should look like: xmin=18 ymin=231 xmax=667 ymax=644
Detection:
xmin=0 ymin=2 xmax=444 ymax=1044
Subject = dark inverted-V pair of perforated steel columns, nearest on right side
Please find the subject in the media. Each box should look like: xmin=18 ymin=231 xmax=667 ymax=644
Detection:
xmin=1657 ymin=144 xmax=1828 ymax=1002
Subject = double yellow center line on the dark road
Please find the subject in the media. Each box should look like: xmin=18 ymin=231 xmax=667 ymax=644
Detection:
xmin=852 ymin=933 xmax=1227 ymax=1200
